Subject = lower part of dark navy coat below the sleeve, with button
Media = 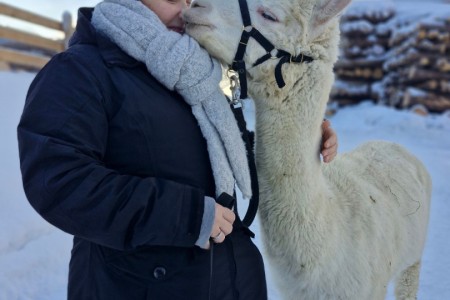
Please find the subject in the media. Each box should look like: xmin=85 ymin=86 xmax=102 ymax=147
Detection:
xmin=68 ymin=230 xmax=267 ymax=300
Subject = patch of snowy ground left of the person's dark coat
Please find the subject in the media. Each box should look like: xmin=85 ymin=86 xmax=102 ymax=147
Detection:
xmin=0 ymin=72 xmax=71 ymax=300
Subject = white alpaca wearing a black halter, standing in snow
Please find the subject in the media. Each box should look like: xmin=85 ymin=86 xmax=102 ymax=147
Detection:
xmin=185 ymin=0 xmax=431 ymax=300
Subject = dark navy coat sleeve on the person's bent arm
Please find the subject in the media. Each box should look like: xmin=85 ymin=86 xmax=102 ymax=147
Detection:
xmin=18 ymin=54 xmax=204 ymax=249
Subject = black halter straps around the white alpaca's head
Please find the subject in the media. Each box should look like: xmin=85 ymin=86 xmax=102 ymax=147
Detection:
xmin=230 ymin=0 xmax=313 ymax=99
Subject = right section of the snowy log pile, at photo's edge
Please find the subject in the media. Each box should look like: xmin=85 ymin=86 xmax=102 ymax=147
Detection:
xmin=383 ymin=11 xmax=450 ymax=112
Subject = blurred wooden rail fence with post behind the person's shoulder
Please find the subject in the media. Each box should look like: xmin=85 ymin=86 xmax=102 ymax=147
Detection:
xmin=0 ymin=2 xmax=73 ymax=70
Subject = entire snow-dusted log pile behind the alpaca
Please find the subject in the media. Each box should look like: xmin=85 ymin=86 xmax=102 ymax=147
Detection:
xmin=331 ymin=1 xmax=450 ymax=113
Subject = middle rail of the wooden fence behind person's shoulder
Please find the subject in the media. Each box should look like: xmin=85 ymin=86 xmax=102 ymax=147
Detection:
xmin=0 ymin=26 xmax=65 ymax=52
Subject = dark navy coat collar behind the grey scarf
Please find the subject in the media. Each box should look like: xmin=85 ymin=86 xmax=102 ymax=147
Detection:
xmin=69 ymin=7 xmax=142 ymax=68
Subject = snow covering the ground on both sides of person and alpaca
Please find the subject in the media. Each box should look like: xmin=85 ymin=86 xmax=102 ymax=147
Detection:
xmin=0 ymin=72 xmax=450 ymax=300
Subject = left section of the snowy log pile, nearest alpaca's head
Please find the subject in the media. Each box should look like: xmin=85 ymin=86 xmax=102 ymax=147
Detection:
xmin=331 ymin=3 xmax=395 ymax=105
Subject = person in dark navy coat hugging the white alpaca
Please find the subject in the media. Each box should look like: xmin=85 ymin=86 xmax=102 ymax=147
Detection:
xmin=18 ymin=0 xmax=337 ymax=300
